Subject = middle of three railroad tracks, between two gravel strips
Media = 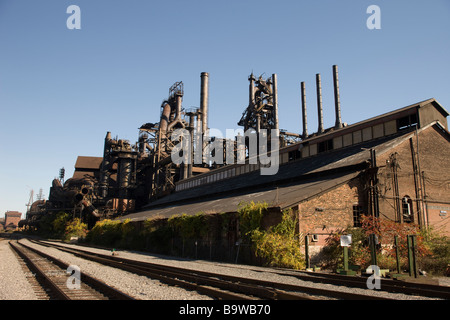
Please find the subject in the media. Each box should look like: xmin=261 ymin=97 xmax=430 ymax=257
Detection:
xmin=27 ymin=240 xmax=400 ymax=300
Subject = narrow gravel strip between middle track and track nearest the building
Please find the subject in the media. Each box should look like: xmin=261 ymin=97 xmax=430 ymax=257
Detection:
xmin=32 ymin=240 xmax=446 ymax=300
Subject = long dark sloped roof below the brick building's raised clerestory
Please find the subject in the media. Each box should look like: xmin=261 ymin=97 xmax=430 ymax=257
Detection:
xmin=120 ymin=123 xmax=442 ymax=221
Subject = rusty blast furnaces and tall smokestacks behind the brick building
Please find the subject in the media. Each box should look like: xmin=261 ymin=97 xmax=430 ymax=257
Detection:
xmin=30 ymin=66 xmax=352 ymax=228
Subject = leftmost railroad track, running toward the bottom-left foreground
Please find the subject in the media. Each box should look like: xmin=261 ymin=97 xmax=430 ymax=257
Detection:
xmin=9 ymin=241 xmax=134 ymax=300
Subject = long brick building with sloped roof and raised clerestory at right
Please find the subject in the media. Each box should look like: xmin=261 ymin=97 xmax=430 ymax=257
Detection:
xmin=122 ymin=99 xmax=450 ymax=258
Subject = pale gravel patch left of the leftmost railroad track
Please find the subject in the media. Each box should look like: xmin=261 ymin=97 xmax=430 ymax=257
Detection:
xmin=0 ymin=238 xmax=37 ymax=300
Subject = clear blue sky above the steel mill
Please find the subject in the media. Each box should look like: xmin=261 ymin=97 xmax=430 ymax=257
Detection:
xmin=0 ymin=0 xmax=450 ymax=217
